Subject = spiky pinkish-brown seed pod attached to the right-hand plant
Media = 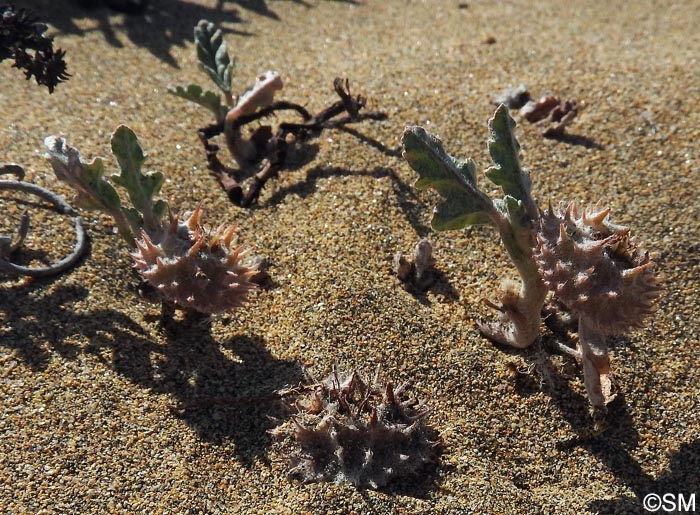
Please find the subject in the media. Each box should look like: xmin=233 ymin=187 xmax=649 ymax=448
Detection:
xmin=534 ymin=202 xmax=660 ymax=334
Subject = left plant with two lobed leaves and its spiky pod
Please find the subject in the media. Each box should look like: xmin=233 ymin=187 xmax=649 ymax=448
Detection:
xmin=45 ymin=125 xmax=258 ymax=314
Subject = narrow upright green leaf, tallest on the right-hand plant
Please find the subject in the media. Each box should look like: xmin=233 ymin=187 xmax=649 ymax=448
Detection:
xmin=485 ymin=104 xmax=537 ymax=218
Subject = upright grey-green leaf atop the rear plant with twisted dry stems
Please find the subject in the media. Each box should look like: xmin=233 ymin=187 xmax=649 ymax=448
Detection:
xmin=194 ymin=20 xmax=234 ymax=95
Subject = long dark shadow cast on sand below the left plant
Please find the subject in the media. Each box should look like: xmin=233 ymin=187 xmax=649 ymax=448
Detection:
xmin=0 ymin=280 xmax=303 ymax=464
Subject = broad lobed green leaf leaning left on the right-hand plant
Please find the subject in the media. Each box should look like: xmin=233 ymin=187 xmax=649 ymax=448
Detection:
xmin=401 ymin=127 xmax=493 ymax=231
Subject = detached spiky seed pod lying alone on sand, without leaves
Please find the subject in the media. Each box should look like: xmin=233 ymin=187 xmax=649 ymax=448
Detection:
xmin=280 ymin=371 xmax=437 ymax=488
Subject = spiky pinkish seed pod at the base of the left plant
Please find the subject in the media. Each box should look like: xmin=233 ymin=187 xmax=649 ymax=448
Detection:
xmin=131 ymin=207 xmax=258 ymax=314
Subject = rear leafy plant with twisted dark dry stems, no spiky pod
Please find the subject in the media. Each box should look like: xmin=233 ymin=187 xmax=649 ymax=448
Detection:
xmin=169 ymin=20 xmax=386 ymax=207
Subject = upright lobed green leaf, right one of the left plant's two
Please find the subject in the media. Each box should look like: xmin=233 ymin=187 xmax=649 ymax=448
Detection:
xmin=111 ymin=125 xmax=163 ymax=217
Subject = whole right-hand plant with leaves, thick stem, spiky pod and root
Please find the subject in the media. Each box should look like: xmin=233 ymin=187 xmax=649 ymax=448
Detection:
xmin=402 ymin=105 xmax=660 ymax=408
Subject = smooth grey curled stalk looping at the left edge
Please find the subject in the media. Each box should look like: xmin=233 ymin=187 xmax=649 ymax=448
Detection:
xmin=0 ymin=165 xmax=87 ymax=277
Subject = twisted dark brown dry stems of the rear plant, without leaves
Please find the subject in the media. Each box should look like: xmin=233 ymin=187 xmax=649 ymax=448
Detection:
xmin=198 ymin=78 xmax=386 ymax=207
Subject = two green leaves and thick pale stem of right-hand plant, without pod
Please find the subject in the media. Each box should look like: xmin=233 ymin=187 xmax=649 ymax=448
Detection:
xmin=402 ymin=105 xmax=547 ymax=348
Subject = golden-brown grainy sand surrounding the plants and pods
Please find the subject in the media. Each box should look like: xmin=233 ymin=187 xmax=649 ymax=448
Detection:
xmin=0 ymin=0 xmax=700 ymax=515
